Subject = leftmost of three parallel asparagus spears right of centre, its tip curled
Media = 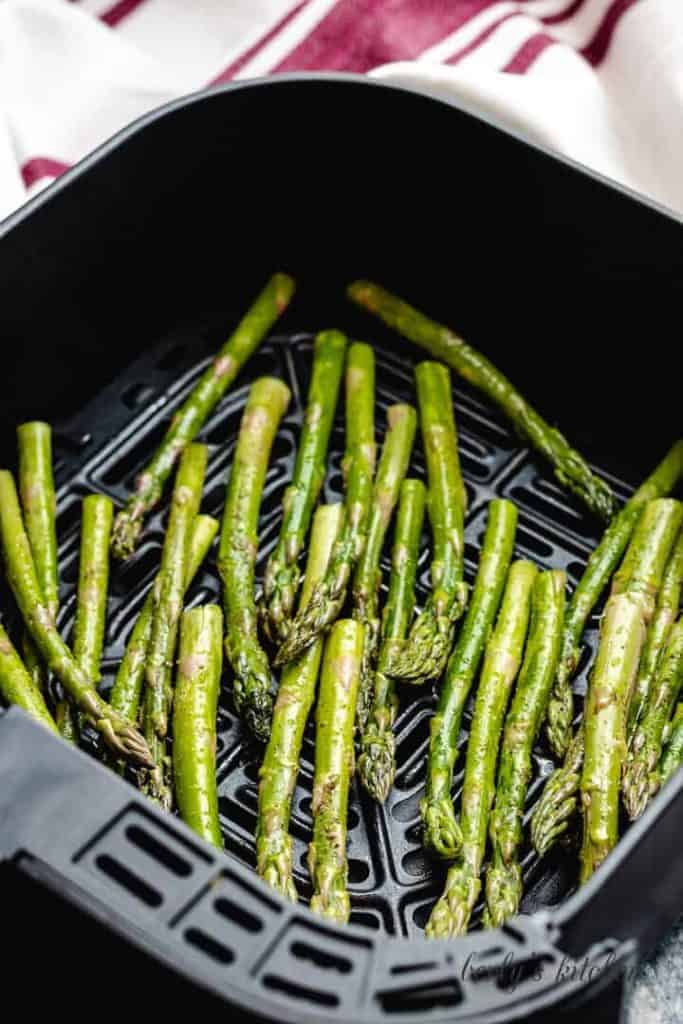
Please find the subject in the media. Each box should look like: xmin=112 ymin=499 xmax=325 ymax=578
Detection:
xmin=420 ymin=499 xmax=517 ymax=860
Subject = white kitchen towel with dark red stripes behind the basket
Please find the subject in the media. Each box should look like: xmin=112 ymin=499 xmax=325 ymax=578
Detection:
xmin=0 ymin=0 xmax=683 ymax=217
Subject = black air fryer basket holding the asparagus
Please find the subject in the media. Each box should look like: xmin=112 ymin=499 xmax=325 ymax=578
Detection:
xmin=0 ymin=76 xmax=683 ymax=1022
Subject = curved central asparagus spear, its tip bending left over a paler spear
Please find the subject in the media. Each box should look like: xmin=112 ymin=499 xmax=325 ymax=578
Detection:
xmin=275 ymin=342 xmax=375 ymax=665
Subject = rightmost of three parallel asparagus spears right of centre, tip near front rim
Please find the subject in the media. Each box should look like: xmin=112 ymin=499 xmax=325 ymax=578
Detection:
xmin=484 ymin=570 xmax=566 ymax=928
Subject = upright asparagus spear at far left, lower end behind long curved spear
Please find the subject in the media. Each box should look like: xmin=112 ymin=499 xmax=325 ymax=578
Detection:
xmin=16 ymin=422 xmax=59 ymax=692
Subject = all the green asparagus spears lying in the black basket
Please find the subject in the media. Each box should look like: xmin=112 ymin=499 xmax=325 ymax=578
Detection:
xmin=0 ymin=274 xmax=683 ymax=936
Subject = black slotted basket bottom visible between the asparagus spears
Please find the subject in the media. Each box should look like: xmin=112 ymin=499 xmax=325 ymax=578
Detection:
xmin=49 ymin=317 xmax=629 ymax=936
